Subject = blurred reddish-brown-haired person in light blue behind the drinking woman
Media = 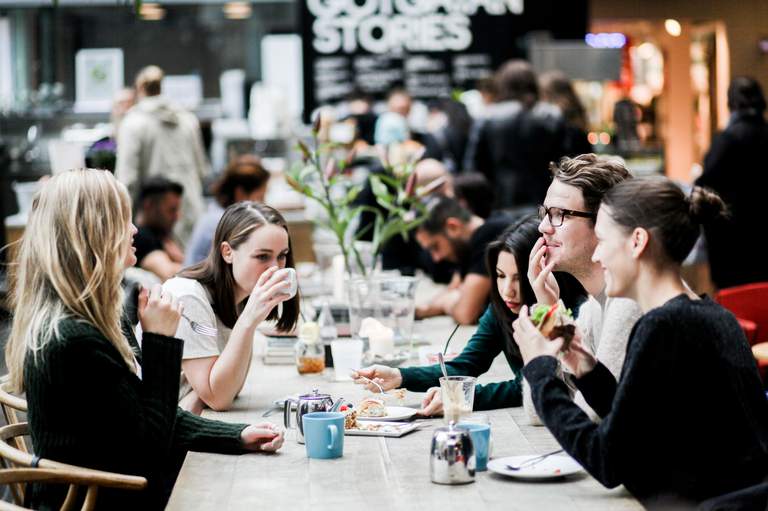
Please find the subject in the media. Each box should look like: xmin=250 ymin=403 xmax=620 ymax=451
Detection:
xmin=184 ymin=154 xmax=269 ymax=266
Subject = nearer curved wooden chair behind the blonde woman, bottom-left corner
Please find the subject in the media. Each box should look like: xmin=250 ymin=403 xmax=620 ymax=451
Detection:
xmin=0 ymin=422 xmax=147 ymax=511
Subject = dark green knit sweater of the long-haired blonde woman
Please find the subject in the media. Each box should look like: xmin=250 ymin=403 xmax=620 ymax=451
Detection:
xmin=24 ymin=319 xmax=246 ymax=510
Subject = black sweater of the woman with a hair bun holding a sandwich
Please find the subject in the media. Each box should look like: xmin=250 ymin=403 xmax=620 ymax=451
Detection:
xmin=523 ymin=295 xmax=768 ymax=509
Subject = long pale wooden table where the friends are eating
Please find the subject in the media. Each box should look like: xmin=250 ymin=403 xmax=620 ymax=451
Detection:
xmin=167 ymin=317 xmax=642 ymax=511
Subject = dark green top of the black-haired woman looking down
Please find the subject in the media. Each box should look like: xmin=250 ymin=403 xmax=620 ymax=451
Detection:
xmin=400 ymin=306 xmax=523 ymax=410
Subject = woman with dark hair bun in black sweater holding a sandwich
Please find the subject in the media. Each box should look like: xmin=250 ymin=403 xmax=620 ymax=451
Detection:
xmin=514 ymin=178 xmax=768 ymax=510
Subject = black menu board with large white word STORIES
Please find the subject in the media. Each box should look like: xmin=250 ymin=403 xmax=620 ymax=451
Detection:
xmin=301 ymin=0 xmax=587 ymax=116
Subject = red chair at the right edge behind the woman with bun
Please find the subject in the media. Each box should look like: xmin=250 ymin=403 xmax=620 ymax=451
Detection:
xmin=715 ymin=282 xmax=768 ymax=381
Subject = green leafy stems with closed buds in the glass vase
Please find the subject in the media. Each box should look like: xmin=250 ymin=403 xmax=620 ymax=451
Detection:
xmin=286 ymin=130 xmax=426 ymax=276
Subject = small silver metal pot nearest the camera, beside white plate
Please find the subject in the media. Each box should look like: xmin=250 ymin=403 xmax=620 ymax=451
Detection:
xmin=429 ymin=421 xmax=476 ymax=484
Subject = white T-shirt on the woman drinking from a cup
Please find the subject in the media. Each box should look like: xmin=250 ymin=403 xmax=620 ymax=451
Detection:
xmin=163 ymin=277 xmax=232 ymax=399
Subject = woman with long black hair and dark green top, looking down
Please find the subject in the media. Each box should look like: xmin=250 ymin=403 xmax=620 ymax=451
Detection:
xmin=356 ymin=217 xmax=586 ymax=415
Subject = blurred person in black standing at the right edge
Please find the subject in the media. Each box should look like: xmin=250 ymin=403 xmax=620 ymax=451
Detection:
xmin=696 ymin=77 xmax=768 ymax=289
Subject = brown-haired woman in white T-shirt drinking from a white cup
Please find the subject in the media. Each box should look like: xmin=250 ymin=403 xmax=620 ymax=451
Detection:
xmin=163 ymin=201 xmax=299 ymax=413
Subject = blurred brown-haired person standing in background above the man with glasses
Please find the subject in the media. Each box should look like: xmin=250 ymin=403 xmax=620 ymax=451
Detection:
xmin=539 ymin=71 xmax=592 ymax=156
